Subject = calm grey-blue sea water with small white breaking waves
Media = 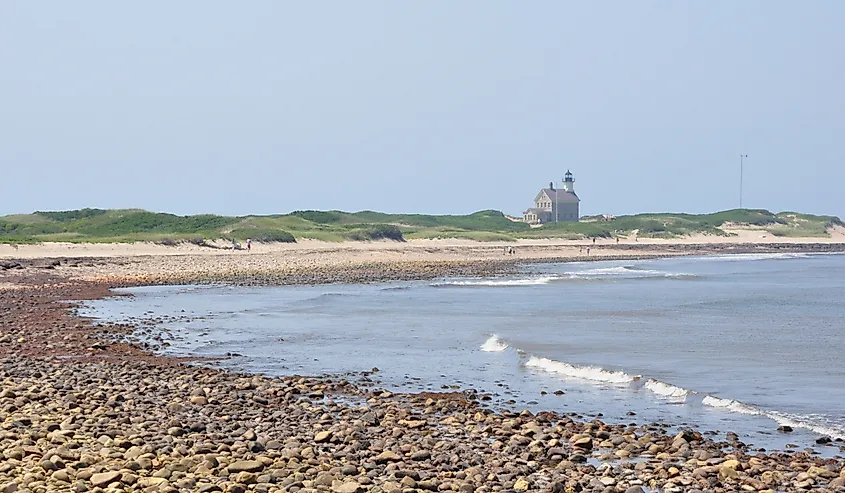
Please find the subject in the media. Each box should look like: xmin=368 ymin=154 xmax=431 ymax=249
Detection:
xmin=82 ymin=254 xmax=845 ymax=455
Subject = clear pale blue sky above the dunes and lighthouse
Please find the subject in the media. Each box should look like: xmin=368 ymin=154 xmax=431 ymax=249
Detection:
xmin=0 ymin=0 xmax=845 ymax=216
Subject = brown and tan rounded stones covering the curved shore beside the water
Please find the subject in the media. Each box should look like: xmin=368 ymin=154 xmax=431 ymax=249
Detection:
xmin=0 ymin=249 xmax=845 ymax=493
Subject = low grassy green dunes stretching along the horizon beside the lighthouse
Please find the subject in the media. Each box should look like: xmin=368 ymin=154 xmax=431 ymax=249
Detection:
xmin=0 ymin=209 xmax=845 ymax=245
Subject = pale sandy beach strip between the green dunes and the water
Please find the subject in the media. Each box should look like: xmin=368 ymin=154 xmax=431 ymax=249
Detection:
xmin=0 ymin=236 xmax=845 ymax=287
